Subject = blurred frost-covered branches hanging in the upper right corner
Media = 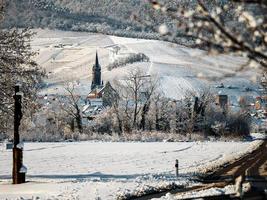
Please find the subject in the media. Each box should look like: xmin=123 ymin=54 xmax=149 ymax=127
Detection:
xmin=150 ymin=0 xmax=267 ymax=69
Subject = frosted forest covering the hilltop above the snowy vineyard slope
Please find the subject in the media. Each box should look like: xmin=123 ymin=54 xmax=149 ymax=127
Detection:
xmin=1 ymin=0 xmax=221 ymax=46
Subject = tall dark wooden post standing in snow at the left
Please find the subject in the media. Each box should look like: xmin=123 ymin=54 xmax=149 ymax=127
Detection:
xmin=12 ymin=85 xmax=25 ymax=184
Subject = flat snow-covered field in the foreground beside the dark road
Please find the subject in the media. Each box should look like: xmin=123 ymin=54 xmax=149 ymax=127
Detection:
xmin=0 ymin=141 xmax=258 ymax=200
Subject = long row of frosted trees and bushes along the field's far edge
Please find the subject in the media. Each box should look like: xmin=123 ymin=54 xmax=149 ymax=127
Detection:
xmin=2 ymin=70 xmax=251 ymax=141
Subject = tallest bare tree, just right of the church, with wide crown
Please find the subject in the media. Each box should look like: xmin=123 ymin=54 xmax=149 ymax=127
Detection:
xmin=113 ymin=69 xmax=157 ymax=131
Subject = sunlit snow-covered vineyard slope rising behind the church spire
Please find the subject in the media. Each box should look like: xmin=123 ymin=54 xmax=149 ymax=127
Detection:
xmin=32 ymin=30 xmax=262 ymax=99
